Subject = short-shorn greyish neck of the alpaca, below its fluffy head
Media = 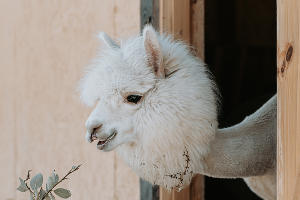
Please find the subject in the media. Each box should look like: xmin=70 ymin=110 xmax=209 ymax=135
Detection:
xmin=199 ymin=96 xmax=277 ymax=178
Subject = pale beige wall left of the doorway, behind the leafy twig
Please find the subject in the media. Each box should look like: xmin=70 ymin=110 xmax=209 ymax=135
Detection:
xmin=0 ymin=0 xmax=139 ymax=200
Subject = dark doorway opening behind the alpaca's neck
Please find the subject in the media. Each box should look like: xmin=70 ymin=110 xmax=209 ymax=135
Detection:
xmin=205 ymin=0 xmax=276 ymax=200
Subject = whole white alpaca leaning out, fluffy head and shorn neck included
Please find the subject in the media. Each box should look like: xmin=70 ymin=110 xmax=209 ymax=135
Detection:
xmin=80 ymin=26 xmax=276 ymax=199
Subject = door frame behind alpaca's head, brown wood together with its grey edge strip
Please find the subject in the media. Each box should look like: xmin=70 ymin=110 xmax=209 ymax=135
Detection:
xmin=140 ymin=0 xmax=204 ymax=200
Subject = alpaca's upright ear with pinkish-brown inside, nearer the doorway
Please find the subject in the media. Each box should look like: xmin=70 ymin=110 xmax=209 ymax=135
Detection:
xmin=143 ymin=25 xmax=165 ymax=78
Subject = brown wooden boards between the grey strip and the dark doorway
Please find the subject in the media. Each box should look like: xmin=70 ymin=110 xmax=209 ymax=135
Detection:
xmin=159 ymin=0 xmax=204 ymax=200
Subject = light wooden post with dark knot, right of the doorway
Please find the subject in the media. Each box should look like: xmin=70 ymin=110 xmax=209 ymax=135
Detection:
xmin=277 ymin=0 xmax=300 ymax=200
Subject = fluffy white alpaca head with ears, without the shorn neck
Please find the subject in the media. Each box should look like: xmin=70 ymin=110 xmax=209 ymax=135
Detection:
xmin=80 ymin=26 xmax=217 ymax=189
